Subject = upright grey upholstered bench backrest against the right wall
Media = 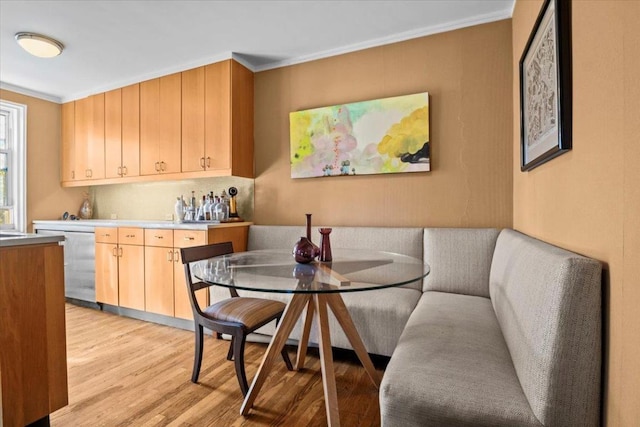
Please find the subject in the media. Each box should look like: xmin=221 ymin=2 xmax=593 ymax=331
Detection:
xmin=489 ymin=229 xmax=602 ymax=426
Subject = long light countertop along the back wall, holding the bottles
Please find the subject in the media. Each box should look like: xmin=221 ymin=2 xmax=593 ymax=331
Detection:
xmin=33 ymin=219 xmax=252 ymax=233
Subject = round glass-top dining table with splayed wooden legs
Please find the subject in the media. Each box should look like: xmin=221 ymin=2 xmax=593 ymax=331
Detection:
xmin=191 ymin=249 xmax=429 ymax=426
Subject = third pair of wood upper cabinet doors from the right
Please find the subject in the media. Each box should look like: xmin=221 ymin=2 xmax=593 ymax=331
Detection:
xmin=105 ymin=84 xmax=140 ymax=178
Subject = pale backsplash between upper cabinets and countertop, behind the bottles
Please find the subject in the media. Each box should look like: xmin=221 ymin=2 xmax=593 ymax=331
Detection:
xmin=89 ymin=177 xmax=254 ymax=221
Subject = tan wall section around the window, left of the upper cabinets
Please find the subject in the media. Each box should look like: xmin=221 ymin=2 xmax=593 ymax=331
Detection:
xmin=0 ymin=90 xmax=87 ymax=230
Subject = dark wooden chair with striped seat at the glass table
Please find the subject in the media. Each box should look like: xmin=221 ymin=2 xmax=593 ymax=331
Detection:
xmin=180 ymin=242 xmax=293 ymax=395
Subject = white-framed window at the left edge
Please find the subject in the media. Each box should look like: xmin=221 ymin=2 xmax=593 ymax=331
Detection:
xmin=0 ymin=101 xmax=27 ymax=232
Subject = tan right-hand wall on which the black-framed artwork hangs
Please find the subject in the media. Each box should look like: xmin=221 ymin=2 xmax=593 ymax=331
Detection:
xmin=513 ymin=0 xmax=640 ymax=427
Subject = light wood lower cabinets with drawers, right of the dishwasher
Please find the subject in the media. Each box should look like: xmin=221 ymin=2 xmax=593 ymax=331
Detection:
xmin=95 ymin=225 xmax=249 ymax=320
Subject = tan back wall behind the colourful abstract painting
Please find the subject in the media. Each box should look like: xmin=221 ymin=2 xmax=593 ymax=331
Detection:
xmin=254 ymin=20 xmax=512 ymax=227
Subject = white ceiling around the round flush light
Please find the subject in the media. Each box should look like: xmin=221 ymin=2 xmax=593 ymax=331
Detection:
xmin=0 ymin=0 xmax=514 ymax=102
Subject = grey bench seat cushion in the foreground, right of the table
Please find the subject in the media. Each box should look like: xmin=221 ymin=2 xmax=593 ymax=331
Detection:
xmin=380 ymin=291 xmax=541 ymax=427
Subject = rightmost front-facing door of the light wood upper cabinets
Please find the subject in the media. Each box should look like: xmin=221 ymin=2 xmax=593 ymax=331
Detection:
xmin=205 ymin=60 xmax=231 ymax=169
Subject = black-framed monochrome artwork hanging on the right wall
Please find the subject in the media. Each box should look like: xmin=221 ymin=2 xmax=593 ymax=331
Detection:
xmin=520 ymin=0 xmax=572 ymax=171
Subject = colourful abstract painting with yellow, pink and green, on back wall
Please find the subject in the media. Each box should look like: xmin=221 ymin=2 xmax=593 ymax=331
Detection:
xmin=289 ymin=92 xmax=430 ymax=178
